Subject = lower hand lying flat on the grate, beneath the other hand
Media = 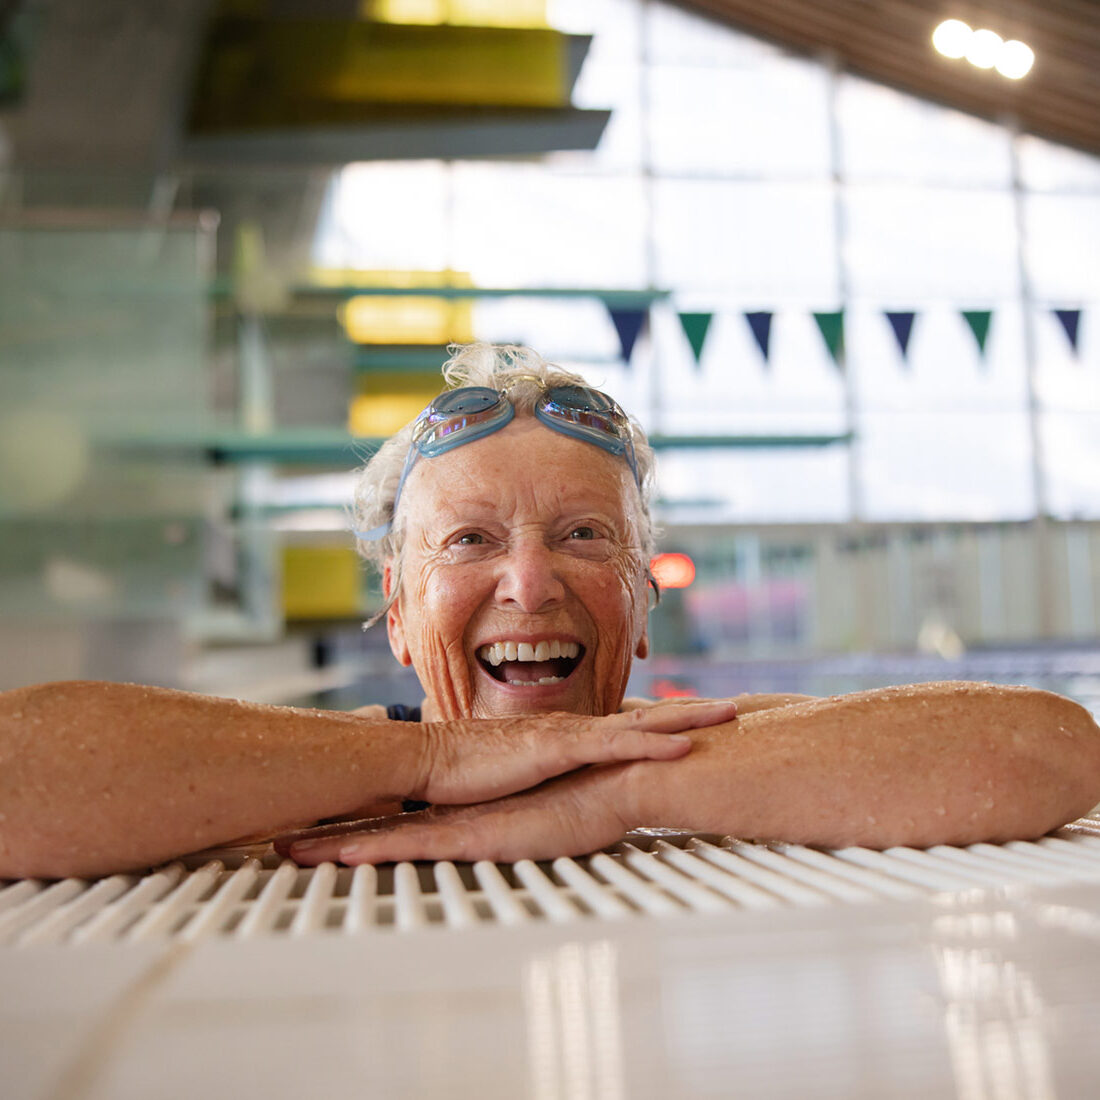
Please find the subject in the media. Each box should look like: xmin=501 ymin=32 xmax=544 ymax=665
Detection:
xmin=276 ymin=763 xmax=638 ymax=867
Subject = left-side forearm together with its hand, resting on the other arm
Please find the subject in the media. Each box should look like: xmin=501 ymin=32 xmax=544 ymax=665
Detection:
xmin=0 ymin=681 xmax=735 ymax=878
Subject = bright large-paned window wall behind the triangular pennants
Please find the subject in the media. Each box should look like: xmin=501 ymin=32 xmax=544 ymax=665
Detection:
xmin=316 ymin=0 xmax=1100 ymax=524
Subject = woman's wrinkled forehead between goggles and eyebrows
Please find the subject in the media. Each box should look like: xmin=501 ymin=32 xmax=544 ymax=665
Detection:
xmin=403 ymin=413 xmax=641 ymax=530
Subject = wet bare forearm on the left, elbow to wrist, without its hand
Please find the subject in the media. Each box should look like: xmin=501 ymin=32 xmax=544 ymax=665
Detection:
xmin=0 ymin=681 xmax=417 ymax=877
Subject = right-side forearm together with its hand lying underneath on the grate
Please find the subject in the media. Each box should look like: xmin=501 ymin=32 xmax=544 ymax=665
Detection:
xmin=290 ymin=683 xmax=1100 ymax=864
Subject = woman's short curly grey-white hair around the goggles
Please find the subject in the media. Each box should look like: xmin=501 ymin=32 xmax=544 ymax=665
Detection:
xmin=352 ymin=343 xmax=657 ymax=626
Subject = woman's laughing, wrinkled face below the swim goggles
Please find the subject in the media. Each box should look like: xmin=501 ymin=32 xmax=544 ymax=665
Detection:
xmin=386 ymin=416 xmax=649 ymax=718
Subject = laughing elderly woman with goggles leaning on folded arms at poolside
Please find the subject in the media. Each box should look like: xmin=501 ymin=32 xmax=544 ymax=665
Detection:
xmin=0 ymin=345 xmax=1100 ymax=876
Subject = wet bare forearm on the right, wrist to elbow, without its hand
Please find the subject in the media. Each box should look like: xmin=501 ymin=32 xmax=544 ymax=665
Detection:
xmin=627 ymin=682 xmax=1100 ymax=848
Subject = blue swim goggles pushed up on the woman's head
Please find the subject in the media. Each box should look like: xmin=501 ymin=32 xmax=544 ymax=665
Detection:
xmin=355 ymin=385 xmax=641 ymax=541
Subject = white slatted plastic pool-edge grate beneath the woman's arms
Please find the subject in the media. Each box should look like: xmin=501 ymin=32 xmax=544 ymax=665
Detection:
xmin=0 ymin=812 xmax=1100 ymax=947
